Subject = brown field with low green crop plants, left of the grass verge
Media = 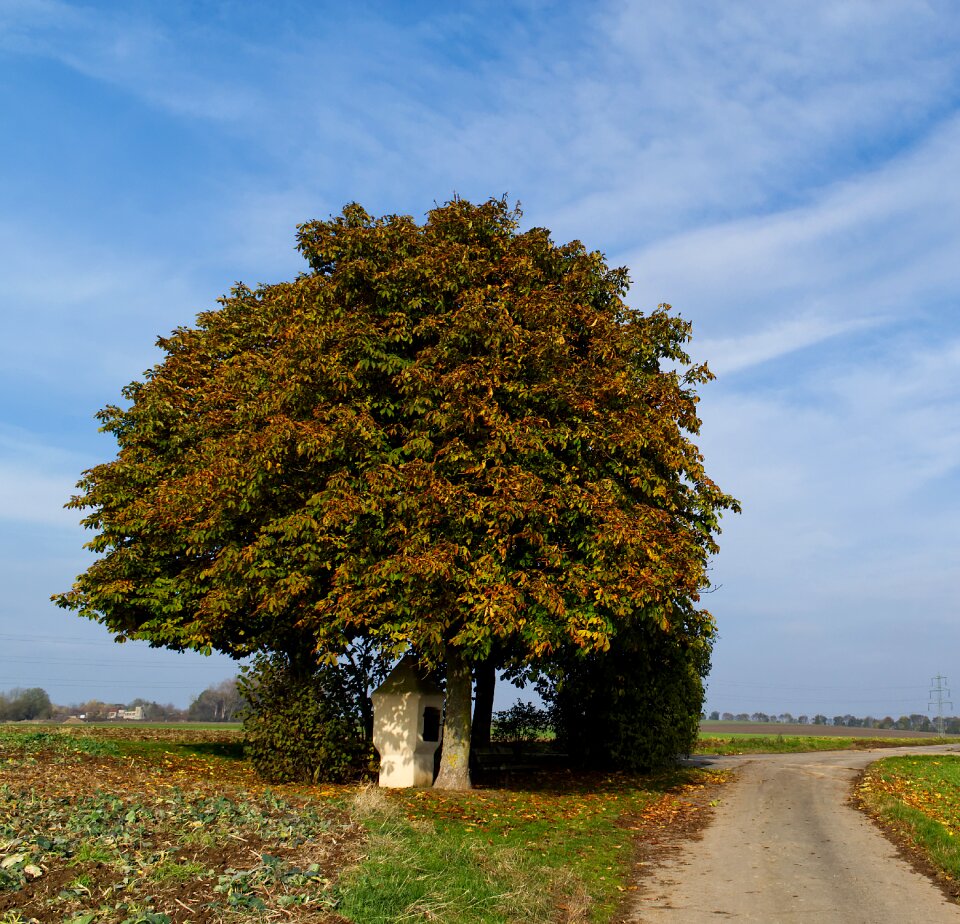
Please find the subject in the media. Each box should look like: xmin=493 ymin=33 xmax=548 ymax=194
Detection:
xmin=0 ymin=730 xmax=363 ymax=924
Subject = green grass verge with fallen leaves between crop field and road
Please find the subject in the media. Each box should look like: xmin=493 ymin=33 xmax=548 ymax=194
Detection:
xmin=338 ymin=770 xmax=718 ymax=924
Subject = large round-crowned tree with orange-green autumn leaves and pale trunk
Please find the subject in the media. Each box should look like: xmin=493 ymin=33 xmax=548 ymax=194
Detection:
xmin=56 ymin=199 xmax=735 ymax=786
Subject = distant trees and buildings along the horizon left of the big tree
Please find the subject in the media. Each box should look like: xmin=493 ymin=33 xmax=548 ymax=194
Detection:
xmin=0 ymin=677 xmax=243 ymax=722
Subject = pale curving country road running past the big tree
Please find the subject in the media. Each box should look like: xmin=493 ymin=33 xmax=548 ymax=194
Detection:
xmin=630 ymin=745 xmax=960 ymax=924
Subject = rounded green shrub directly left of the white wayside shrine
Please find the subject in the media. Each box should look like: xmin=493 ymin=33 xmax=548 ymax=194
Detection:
xmin=240 ymin=655 xmax=373 ymax=783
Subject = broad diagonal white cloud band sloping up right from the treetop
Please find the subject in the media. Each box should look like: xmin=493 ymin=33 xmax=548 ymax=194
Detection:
xmin=625 ymin=110 xmax=960 ymax=362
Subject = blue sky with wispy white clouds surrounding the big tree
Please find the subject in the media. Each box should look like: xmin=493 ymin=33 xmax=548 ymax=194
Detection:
xmin=0 ymin=0 xmax=960 ymax=716
